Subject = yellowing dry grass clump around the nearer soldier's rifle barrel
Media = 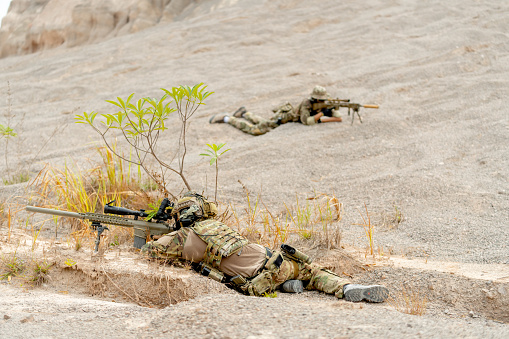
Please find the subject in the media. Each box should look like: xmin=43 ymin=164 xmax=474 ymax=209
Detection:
xmin=26 ymin=147 xmax=160 ymax=250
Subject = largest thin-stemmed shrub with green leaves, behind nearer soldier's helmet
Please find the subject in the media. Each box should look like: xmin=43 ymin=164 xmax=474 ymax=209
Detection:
xmin=76 ymin=83 xmax=213 ymax=198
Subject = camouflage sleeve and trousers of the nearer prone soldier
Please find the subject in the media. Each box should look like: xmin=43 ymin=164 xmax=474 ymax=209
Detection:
xmin=142 ymin=219 xmax=351 ymax=298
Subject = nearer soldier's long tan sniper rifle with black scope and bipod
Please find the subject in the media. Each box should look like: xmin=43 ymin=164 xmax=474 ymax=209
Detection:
xmin=26 ymin=198 xmax=179 ymax=252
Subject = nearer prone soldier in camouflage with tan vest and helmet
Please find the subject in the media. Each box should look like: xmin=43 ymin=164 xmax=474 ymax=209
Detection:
xmin=142 ymin=192 xmax=388 ymax=302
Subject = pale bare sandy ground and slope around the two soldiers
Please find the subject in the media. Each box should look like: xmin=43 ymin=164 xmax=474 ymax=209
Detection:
xmin=0 ymin=0 xmax=509 ymax=338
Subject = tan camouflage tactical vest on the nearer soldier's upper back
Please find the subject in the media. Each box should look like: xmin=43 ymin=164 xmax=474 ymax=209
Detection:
xmin=191 ymin=219 xmax=249 ymax=269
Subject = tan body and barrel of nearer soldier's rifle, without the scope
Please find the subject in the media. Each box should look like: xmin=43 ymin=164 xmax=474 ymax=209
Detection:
xmin=26 ymin=206 xmax=174 ymax=252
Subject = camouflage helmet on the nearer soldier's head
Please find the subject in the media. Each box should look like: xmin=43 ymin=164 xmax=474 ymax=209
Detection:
xmin=172 ymin=191 xmax=217 ymax=227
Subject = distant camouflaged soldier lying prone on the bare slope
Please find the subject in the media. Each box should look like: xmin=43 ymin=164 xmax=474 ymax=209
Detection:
xmin=209 ymin=86 xmax=342 ymax=135
